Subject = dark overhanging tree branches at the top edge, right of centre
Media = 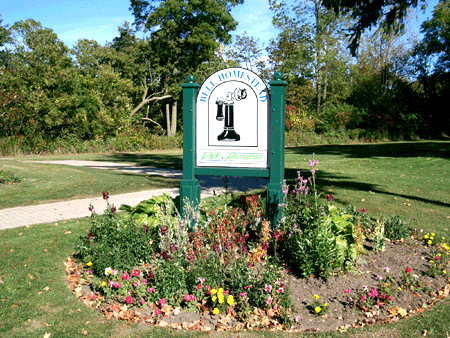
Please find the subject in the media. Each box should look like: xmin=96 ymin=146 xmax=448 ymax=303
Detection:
xmin=322 ymin=0 xmax=426 ymax=56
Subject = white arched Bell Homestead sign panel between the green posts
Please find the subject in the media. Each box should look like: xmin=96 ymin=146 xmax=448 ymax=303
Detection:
xmin=196 ymin=68 xmax=269 ymax=168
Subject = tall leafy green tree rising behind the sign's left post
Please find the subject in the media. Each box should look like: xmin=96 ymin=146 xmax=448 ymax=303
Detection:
xmin=130 ymin=0 xmax=243 ymax=136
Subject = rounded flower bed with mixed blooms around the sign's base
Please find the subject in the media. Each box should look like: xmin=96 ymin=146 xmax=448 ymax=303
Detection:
xmin=65 ymin=160 xmax=450 ymax=331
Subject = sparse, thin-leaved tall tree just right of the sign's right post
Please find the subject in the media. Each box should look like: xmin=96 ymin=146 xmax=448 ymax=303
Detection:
xmin=268 ymin=0 xmax=349 ymax=125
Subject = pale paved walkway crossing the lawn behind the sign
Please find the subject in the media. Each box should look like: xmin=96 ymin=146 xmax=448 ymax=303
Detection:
xmin=0 ymin=161 xmax=268 ymax=230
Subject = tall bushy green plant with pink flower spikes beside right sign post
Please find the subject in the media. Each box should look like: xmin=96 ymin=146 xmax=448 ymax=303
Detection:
xmin=280 ymin=157 xmax=365 ymax=278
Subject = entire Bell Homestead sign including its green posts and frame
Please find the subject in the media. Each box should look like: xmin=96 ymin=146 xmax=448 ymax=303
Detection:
xmin=180 ymin=68 xmax=287 ymax=224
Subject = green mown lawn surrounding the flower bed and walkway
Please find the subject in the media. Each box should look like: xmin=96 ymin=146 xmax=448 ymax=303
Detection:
xmin=0 ymin=142 xmax=450 ymax=338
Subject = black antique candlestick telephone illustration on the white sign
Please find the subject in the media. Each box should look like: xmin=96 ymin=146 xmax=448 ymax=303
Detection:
xmin=216 ymin=88 xmax=247 ymax=141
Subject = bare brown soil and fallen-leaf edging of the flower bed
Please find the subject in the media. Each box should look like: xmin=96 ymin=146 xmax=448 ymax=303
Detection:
xmin=65 ymin=239 xmax=450 ymax=332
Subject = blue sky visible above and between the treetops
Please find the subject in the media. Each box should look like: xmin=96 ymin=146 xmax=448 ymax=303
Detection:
xmin=0 ymin=0 xmax=438 ymax=47
